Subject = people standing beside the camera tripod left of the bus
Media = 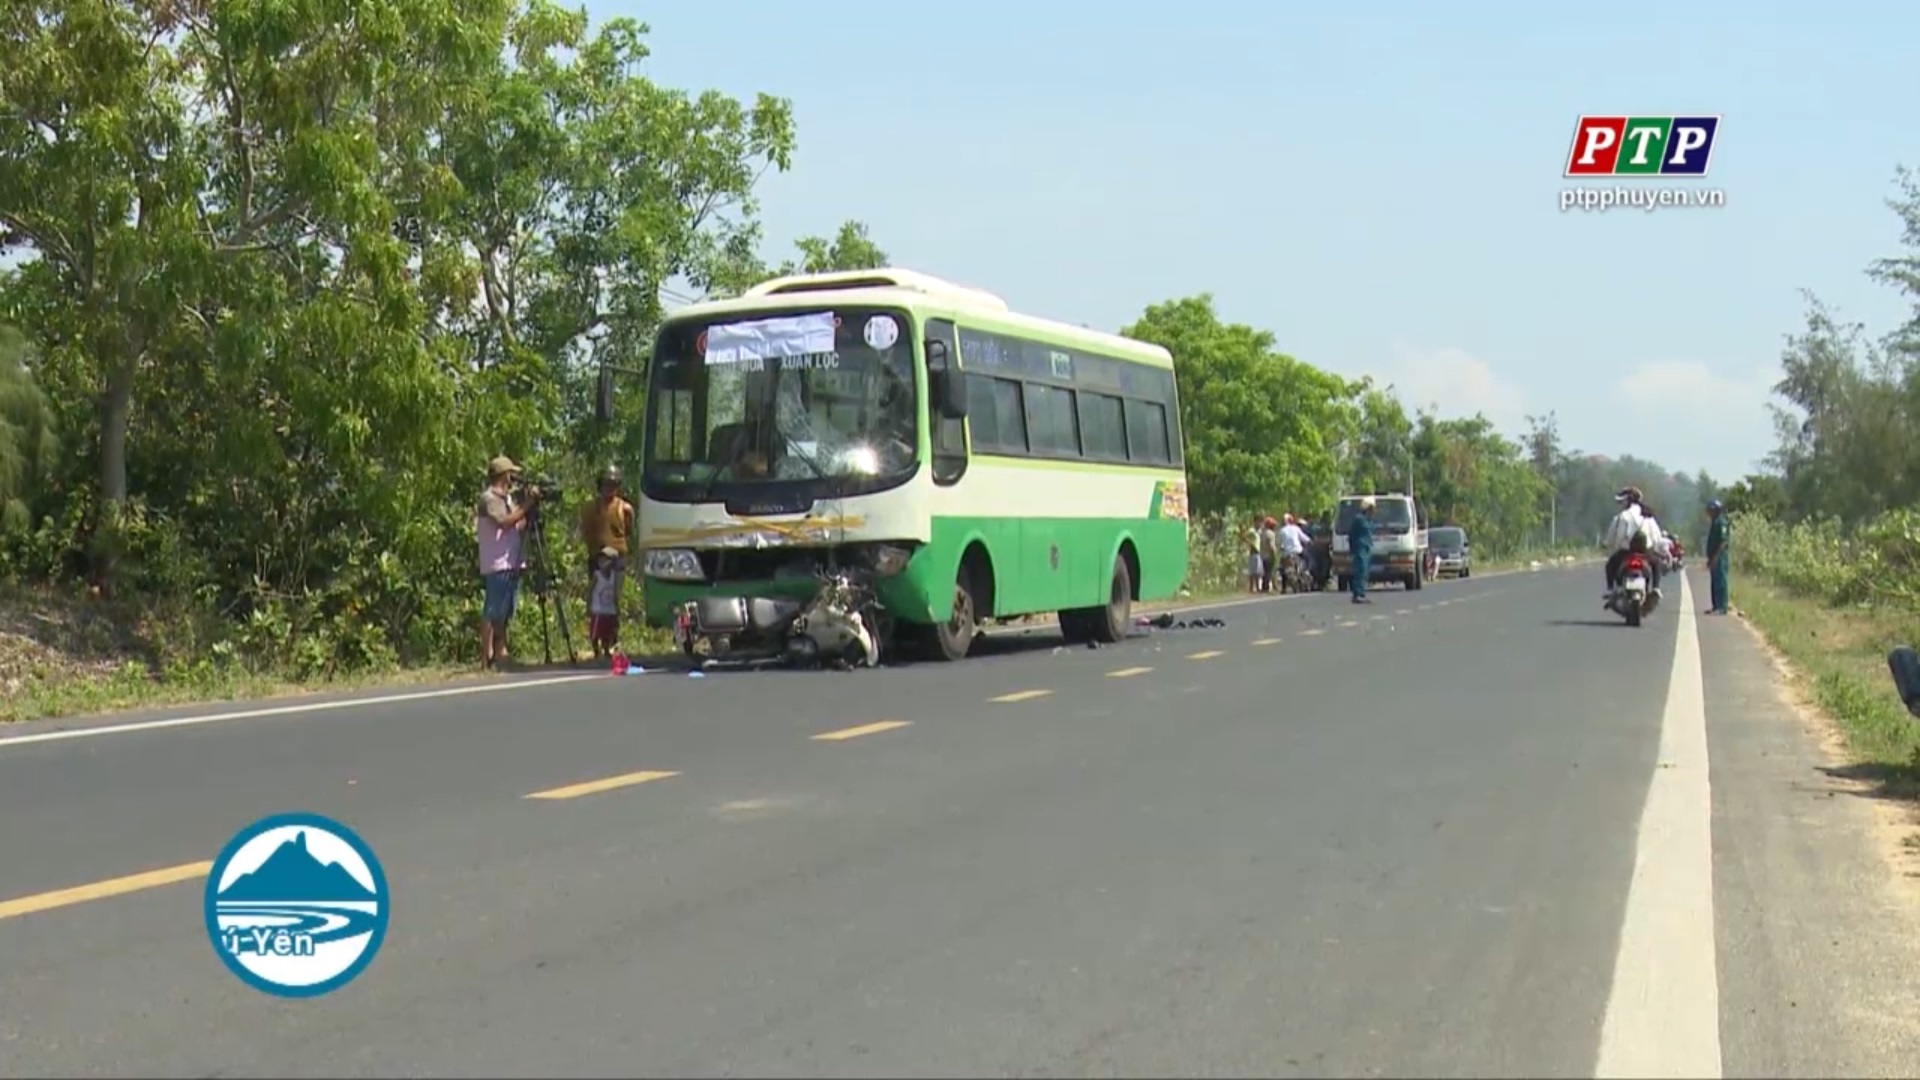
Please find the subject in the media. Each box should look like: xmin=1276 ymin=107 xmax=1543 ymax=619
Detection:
xmin=474 ymin=455 xmax=634 ymax=669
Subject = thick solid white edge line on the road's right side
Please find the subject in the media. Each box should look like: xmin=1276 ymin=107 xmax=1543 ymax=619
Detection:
xmin=1594 ymin=575 xmax=1722 ymax=1080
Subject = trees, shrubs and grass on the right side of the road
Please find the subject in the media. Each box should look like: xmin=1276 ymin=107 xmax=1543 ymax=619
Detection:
xmin=1724 ymin=169 xmax=1920 ymax=798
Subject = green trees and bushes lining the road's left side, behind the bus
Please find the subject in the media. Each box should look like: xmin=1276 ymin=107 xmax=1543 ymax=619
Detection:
xmin=0 ymin=0 xmax=1689 ymax=719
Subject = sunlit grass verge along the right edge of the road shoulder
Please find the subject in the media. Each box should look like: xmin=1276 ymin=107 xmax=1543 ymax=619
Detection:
xmin=1734 ymin=577 xmax=1920 ymax=799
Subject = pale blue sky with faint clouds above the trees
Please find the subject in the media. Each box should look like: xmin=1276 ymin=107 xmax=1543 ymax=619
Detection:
xmin=618 ymin=0 xmax=1920 ymax=479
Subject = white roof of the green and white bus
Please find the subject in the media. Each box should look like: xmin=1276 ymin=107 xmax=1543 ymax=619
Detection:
xmin=666 ymin=267 xmax=1173 ymax=367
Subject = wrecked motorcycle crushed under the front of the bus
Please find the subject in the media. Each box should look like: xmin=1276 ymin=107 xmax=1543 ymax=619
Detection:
xmin=674 ymin=567 xmax=887 ymax=667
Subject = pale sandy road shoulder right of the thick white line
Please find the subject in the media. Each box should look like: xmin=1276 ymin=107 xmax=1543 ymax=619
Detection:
xmin=1699 ymin=584 xmax=1920 ymax=1076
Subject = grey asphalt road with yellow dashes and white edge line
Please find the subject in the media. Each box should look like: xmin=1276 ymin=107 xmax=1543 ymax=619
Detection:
xmin=0 ymin=567 xmax=1920 ymax=1076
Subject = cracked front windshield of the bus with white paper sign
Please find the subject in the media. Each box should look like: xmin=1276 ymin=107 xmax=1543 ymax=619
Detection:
xmin=641 ymin=307 xmax=918 ymax=498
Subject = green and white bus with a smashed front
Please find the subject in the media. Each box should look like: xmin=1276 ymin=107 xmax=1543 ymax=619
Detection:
xmin=603 ymin=269 xmax=1188 ymax=659
